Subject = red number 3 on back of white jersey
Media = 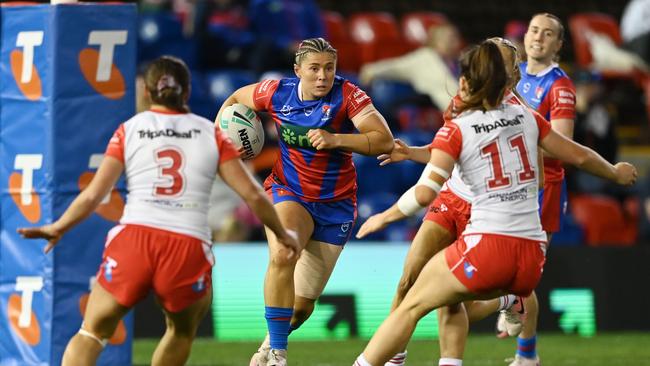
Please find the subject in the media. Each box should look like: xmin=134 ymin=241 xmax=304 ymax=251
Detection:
xmin=153 ymin=146 xmax=185 ymax=197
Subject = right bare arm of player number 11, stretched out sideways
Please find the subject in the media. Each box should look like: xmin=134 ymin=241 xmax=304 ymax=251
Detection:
xmin=541 ymin=130 xmax=637 ymax=185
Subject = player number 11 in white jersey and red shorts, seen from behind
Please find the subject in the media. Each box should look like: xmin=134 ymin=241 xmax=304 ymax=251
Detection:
xmin=355 ymin=41 xmax=636 ymax=366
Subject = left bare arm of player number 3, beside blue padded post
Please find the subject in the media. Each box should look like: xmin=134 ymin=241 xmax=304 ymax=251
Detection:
xmin=17 ymin=156 xmax=124 ymax=253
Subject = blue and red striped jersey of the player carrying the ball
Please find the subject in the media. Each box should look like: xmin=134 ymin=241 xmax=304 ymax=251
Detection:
xmin=253 ymin=76 xmax=372 ymax=202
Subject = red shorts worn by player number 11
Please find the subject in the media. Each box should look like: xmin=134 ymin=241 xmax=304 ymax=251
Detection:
xmin=445 ymin=234 xmax=546 ymax=296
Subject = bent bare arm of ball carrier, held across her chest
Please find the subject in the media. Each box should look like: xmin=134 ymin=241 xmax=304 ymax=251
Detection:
xmin=307 ymin=104 xmax=393 ymax=155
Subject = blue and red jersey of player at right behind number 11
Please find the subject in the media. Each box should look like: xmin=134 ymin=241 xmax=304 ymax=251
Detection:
xmin=517 ymin=62 xmax=576 ymax=182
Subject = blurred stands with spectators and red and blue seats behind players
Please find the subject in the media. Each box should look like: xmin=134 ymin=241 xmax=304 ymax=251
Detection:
xmin=121 ymin=0 xmax=650 ymax=246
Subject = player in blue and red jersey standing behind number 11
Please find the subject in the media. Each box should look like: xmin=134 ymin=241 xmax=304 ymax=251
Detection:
xmin=497 ymin=13 xmax=576 ymax=366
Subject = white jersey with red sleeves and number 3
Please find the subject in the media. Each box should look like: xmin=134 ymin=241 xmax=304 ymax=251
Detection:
xmin=106 ymin=110 xmax=239 ymax=243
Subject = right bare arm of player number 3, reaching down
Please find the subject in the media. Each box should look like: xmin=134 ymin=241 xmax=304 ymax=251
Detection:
xmin=219 ymin=159 xmax=300 ymax=256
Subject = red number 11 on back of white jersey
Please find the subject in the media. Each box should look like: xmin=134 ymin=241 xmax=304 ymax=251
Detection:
xmin=481 ymin=134 xmax=535 ymax=190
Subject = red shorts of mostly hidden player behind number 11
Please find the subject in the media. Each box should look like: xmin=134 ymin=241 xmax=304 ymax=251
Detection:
xmin=424 ymin=190 xmax=472 ymax=238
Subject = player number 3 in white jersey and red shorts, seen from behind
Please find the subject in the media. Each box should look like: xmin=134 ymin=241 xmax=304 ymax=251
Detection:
xmin=18 ymin=57 xmax=298 ymax=366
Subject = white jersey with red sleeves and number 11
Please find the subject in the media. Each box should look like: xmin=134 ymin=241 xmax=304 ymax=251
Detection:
xmin=432 ymin=103 xmax=551 ymax=241
